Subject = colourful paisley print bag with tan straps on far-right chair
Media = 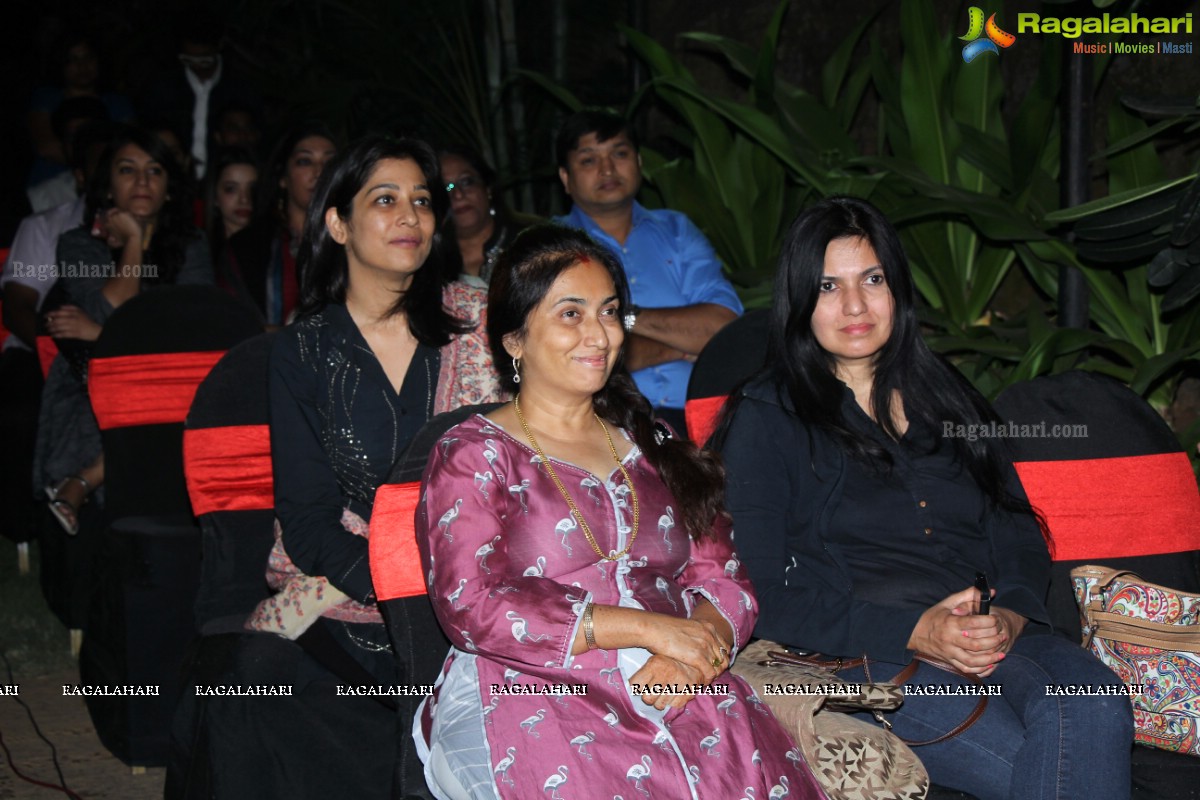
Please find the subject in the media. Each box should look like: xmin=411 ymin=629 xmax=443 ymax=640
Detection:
xmin=1070 ymin=565 xmax=1200 ymax=756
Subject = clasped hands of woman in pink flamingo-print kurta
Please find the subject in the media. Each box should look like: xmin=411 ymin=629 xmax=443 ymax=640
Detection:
xmin=630 ymin=618 xmax=730 ymax=711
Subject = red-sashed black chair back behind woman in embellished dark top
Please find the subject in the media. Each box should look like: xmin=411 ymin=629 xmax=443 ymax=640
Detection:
xmin=184 ymin=333 xmax=275 ymax=632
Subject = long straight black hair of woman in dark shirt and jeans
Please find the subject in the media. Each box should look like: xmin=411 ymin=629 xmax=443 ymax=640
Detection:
xmin=725 ymin=197 xmax=1032 ymax=513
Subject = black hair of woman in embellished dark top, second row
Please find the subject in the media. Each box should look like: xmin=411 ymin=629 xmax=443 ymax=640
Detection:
xmin=296 ymin=136 xmax=468 ymax=347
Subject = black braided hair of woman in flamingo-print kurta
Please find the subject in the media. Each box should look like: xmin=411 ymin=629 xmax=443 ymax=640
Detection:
xmin=487 ymin=224 xmax=725 ymax=539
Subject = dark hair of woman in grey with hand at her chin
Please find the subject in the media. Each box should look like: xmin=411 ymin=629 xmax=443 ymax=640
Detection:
xmin=84 ymin=125 xmax=202 ymax=284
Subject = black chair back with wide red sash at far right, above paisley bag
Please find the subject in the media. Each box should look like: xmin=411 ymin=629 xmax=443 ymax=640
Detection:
xmin=996 ymin=371 xmax=1200 ymax=642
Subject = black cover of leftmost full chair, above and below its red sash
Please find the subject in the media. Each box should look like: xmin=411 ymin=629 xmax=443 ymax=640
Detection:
xmin=79 ymin=287 xmax=262 ymax=766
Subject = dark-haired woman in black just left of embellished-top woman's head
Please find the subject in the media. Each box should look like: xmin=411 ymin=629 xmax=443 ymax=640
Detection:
xmin=217 ymin=121 xmax=337 ymax=326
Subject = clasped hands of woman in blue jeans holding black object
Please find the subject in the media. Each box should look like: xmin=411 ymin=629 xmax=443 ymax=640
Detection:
xmin=908 ymin=587 xmax=1026 ymax=678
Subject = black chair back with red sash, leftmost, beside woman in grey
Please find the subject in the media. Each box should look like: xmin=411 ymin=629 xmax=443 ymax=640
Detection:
xmin=88 ymin=285 xmax=262 ymax=519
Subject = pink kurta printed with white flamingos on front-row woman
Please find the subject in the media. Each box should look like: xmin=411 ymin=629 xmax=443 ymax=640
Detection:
xmin=416 ymin=416 xmax=824 ymax=800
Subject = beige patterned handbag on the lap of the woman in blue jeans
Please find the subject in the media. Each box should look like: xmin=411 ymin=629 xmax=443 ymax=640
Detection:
xmin=732 ymin=639 xmax=929 ymax=800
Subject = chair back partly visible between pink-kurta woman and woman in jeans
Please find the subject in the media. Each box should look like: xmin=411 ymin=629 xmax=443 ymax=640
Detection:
xmin=684 ymin=308 xmax=770 ymax=446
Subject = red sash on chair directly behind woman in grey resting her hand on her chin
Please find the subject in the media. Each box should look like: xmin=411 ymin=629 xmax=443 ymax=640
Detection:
xmin=88 ymin=350 xmax=224 ymax=431
